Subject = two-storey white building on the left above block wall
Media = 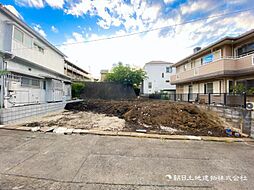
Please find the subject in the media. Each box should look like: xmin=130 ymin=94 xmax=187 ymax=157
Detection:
xmin=0 ymin=4 xmax=71 ymax=113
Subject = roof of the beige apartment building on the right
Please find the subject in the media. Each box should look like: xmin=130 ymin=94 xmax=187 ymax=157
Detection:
xmin=173 ymin=29 xmax=254 ymax=66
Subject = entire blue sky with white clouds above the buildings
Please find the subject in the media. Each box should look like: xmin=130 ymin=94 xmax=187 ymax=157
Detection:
xmin=0 ymin=0 xmax=254 ymax=76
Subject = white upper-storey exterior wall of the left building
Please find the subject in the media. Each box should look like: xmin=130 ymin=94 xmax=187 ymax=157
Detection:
xmin=0 ymin=12 xmax=64 ymax=74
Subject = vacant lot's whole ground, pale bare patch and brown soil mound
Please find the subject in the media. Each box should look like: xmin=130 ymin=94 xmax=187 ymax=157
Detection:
xmin=21 ymin=100 xmax=228 ymax=136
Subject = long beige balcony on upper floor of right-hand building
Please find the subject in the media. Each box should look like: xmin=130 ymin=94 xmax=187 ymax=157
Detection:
xmin=170 ymin=54 xmax=254 ymax=84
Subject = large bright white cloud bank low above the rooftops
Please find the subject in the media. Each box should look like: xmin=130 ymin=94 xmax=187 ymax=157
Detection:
xmin=60 ymin=9 xmax=254 ymax=77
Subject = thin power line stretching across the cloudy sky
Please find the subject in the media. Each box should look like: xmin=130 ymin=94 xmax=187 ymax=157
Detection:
xmin=13 ymin=7 xmax=254 ymax=50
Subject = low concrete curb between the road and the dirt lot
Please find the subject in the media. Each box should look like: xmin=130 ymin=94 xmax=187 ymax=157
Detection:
xmin=0 ymin=126 xmax=254 ymax=143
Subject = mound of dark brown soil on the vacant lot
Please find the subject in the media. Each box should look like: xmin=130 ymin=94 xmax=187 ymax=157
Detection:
xmin=66 ymin=100 xmax=226 ymax=136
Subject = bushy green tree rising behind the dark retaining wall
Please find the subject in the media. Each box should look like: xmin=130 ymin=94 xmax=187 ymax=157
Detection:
xmin=106 ymin=62 xmax=146 ymax=94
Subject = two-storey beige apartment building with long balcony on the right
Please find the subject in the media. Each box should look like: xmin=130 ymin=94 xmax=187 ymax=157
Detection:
xmin=170 ymin=30 xmax=254 ymax=103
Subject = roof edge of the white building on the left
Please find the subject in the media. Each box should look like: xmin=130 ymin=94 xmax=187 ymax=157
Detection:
xmin=0 ymin=3 xmax=66 ymax=57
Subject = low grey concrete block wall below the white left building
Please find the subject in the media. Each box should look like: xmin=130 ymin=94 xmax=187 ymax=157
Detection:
xmin=0 ymin=102 xmax=66 ymax=124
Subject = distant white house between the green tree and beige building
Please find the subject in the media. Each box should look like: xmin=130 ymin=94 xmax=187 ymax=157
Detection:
xmin=142 ymin=61 xmax=176 ymax=95
